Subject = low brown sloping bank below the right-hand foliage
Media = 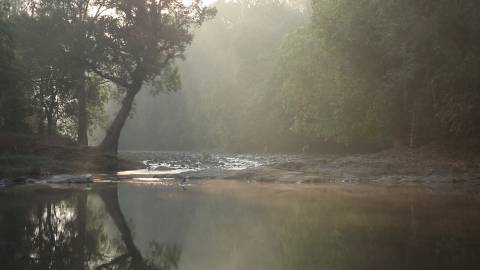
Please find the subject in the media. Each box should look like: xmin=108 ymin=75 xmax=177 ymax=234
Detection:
xmin=231 ymin=145 xmax=480 ymax=188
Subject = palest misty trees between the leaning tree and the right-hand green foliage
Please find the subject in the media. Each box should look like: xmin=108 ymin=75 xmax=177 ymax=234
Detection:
xmin=120 ymin=0 xmax=306 ymax=151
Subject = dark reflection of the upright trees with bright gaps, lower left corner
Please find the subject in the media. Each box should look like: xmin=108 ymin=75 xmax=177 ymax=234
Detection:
xmin=0 ymin=191 xmax=99 ymax=269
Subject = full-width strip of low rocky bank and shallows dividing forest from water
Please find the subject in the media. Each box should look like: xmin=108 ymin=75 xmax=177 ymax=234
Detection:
xmin=0 ymin=132 xmax=480 ymax=189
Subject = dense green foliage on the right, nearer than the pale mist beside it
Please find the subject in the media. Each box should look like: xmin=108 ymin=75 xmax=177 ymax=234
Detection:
xmin=279 ymin=0 xmax=480 ymax=148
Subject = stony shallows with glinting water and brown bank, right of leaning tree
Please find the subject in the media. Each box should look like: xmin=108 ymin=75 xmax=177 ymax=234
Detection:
xmin=111 ymin=146 xmax=480 ymax=189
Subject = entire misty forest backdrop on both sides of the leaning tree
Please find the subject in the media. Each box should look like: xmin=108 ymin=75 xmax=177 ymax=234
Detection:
xmin=0 ymin=0 xmax=480 ymax=152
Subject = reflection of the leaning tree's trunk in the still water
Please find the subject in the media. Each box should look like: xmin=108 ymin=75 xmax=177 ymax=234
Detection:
xmin=97 ymin=188 xmax=180 ymax=270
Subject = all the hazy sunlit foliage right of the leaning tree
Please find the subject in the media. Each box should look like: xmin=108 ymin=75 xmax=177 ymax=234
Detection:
xmin=124 ymin=0 xmax=480 ymax=151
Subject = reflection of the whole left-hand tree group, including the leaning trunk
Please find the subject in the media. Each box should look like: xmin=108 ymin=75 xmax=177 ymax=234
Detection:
xmin=0 ymin=187 xmax=180 ymax=270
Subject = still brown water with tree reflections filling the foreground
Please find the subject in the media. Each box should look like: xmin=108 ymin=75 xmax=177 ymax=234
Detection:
xmin=0 ymin=180 xmax=480 ymax=270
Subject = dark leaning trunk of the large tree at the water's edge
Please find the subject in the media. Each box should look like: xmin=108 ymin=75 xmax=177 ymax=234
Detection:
xmin=100 ymin=82 xmax=142 ymax=156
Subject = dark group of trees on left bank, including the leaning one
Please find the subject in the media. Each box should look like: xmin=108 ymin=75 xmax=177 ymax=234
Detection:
xmin=0 ymin=0 xmax=216 ymax=155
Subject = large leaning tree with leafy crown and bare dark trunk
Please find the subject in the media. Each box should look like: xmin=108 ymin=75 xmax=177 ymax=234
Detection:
xmin=88 ymin=0 xmax=215 ymax=155
